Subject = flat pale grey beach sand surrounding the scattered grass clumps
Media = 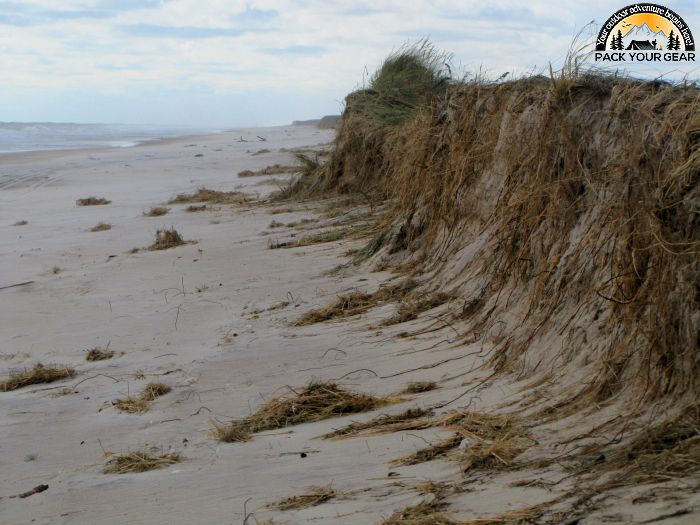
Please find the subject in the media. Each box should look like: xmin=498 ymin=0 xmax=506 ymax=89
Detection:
xmin=0 ymin=127 xmax=697 ymax=524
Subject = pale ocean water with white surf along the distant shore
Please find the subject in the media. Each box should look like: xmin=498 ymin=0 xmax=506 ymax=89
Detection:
xmin=0 ymin=122 xmax=213 ymax=154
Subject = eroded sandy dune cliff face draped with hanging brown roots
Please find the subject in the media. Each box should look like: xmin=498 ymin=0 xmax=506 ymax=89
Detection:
xmin=322 ymin=76 xmax=700 ymax=410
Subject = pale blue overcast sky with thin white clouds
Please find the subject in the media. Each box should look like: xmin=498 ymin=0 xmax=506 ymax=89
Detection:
xmin=0 ymin=0 xmax=700 ymax=128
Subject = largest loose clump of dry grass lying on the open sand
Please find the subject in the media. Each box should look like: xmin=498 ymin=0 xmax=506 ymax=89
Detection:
xmin=213 ymin=383 xmax=390 ymax=443
